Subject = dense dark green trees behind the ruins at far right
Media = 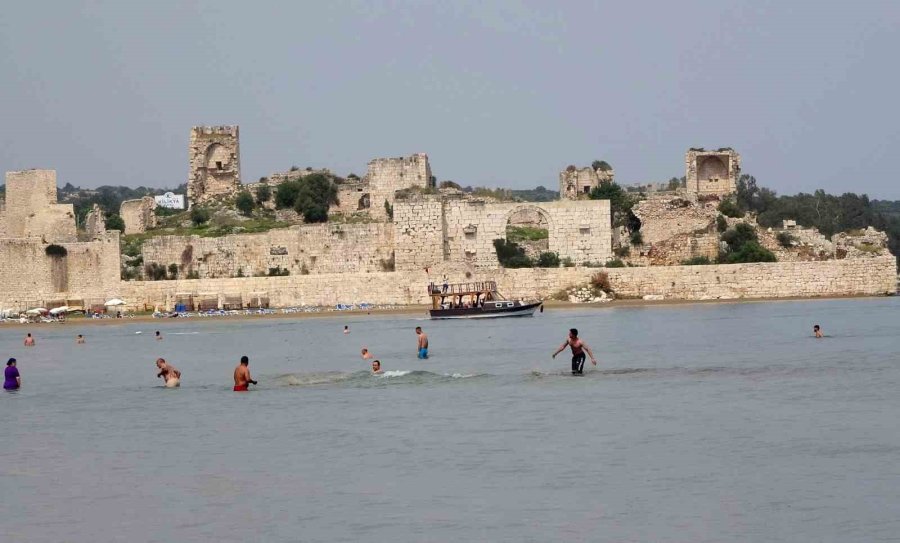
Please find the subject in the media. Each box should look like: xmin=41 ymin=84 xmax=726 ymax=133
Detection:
xmin=734 ymin=175 xmax=900 ymax=256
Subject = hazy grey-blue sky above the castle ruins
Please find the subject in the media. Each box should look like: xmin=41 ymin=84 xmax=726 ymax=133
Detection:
xmin=0 ymin=0 xmax=900 ymax=199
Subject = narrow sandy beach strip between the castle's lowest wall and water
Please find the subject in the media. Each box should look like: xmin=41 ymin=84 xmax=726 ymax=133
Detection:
xmin=7 ymin=295 xmax=892 ymax=326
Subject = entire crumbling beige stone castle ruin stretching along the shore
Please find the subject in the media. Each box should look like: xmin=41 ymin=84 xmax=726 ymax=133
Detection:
xmin=0 ymin=140 xmax=896 ymax=310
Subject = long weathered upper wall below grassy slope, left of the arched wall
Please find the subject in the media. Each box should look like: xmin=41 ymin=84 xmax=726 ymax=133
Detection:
xmin=142 ymin=223 xmax=394 ymax=278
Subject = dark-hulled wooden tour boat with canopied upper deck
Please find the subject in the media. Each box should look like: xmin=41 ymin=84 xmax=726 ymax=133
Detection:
xmin=428 ymin=281 xmax=542 ymax=319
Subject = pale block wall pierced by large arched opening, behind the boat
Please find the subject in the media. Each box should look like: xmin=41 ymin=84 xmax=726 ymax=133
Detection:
xmin=444 ymin=199 xmax=612 ymax=268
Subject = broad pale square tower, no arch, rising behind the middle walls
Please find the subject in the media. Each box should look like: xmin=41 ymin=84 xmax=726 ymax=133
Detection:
xmin=365 ymin=153 xmax=434 ymax=218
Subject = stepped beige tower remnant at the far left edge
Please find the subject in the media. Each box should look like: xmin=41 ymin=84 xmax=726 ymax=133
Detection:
xmin=0 ymin=170 xmax=76 ymax=242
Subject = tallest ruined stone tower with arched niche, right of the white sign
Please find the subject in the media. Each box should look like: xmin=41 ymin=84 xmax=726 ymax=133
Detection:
xmin=188 ymin=126 xmax=241 ymax=205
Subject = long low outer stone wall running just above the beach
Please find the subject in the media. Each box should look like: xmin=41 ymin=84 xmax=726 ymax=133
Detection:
xmin=115 ymin=257 xmax=896 ymax=309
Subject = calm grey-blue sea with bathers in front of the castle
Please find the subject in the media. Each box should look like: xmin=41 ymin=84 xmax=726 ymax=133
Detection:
xmin=0 ymin=298 xmax=900 ymax=543
